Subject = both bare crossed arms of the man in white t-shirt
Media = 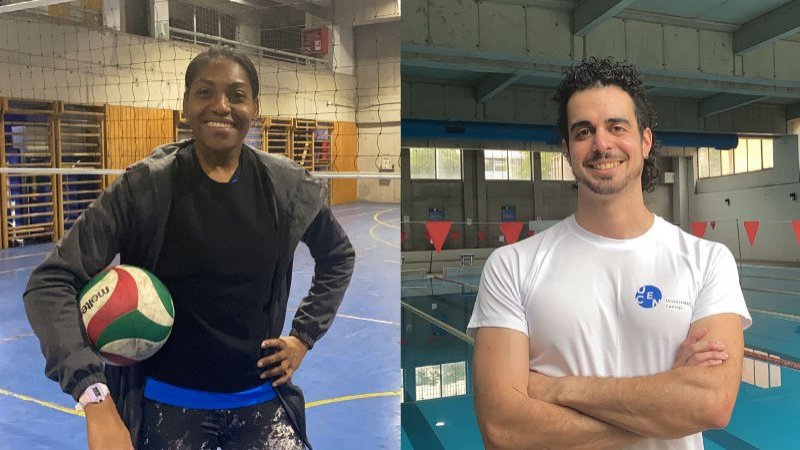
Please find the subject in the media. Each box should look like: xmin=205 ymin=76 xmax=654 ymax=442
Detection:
xmin=474 ymin=314 xmax=743 ymax=449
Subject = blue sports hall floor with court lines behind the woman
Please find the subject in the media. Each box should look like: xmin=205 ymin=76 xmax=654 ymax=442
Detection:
xmin=0 ymin=203 xmax=400 ymax=450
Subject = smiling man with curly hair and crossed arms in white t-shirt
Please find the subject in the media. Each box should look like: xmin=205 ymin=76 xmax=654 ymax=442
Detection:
xmin=469 ymin=58 xmax=751 ymax=449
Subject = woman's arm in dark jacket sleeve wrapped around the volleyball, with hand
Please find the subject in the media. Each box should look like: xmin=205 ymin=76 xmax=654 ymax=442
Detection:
xmin=23 ymin=171 xmax=134 ymax=442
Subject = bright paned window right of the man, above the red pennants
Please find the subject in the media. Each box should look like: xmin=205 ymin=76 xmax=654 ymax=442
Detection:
xmin=695 ymin=138 xmax=773 ymax=178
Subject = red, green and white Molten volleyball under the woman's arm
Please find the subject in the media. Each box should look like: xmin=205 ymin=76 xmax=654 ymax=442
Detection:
xmin=78 ymin=266 xmax=175 ymax=366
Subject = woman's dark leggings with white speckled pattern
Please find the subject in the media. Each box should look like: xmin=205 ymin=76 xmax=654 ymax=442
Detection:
xmin=139 ymin=399 xmax=305 ymax=450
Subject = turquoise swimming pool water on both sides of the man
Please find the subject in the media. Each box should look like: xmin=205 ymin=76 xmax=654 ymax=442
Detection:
xmin=401 ymin=264 xmax=800 ymax=450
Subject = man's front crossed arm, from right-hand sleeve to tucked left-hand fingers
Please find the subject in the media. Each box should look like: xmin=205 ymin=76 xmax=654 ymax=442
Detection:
xmin=528 ymin=314 xmax=744 ymax=439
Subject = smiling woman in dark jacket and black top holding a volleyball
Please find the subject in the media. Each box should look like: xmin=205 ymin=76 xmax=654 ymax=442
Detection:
xmin=24 ymin=47 xmax=355 ymax=449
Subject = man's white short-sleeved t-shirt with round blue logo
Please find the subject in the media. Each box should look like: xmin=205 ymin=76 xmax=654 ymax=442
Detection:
xmin=468 ymin=216 xmax=752 ymax=450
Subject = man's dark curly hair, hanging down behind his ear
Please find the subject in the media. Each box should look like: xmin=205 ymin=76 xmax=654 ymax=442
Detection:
xmin=553 ymin=57 xmax=659 ymax=192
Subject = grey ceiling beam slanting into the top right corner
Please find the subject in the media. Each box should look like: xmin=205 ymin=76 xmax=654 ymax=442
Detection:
xmin=733 ymin=0 xmax=800 ymax=53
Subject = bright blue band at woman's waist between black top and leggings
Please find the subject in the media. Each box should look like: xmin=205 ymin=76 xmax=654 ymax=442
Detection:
xmin=144 ymin=377 xmax=277 ymax=409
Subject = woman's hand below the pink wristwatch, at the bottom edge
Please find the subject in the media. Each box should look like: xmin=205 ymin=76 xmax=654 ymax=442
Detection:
xmin=84 ymin=395 xmax=133 ymax=450
